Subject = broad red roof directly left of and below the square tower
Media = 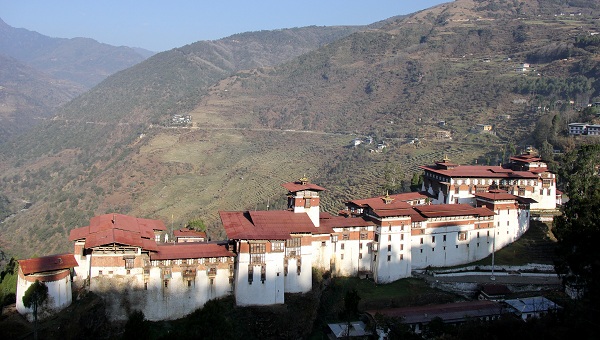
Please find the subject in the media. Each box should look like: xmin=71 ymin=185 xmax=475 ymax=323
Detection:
xmin=219 ymin=210 xmax=319 ymax=240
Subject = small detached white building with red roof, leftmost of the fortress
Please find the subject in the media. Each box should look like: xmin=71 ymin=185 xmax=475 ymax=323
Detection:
xmin=16 ymin=254 xmax=77 ymax=320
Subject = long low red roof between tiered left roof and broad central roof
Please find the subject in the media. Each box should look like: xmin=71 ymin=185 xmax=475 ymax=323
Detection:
xmin=150 ymin=242 xmax=235 ymax=260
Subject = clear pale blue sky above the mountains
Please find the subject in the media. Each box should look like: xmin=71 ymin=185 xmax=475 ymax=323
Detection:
xmin=0 ymin=0 xmax=450 ymax=52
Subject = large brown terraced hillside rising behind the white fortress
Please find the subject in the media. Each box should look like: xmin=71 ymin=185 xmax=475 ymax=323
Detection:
xmin=0 ymin=0 xmax=600 ymax=255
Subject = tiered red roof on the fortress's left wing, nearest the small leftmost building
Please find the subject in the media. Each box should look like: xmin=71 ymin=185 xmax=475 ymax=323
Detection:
xmin=69 ymin=214 xmax=166 ymax=250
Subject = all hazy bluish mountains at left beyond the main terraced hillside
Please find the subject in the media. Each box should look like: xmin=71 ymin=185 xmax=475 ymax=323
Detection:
xmin=0 ymin=19 xmax=152 ymax=143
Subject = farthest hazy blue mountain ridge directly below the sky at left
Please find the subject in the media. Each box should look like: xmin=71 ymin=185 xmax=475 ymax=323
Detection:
xmin=0 ymin=19 xmax=152 ymax=89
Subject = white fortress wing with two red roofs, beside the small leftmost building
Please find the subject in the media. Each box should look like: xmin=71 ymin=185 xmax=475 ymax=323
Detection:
xmin=70 ymin=214 xmax=235 ymax=320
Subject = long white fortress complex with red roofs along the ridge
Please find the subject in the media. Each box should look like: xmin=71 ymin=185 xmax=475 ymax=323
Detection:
xmin=17 ymin=154 xmax=556 ymax=320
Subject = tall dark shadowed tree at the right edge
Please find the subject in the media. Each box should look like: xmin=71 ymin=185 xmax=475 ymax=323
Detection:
xmin=554 ymin=144 xmax=600 ymax=304
